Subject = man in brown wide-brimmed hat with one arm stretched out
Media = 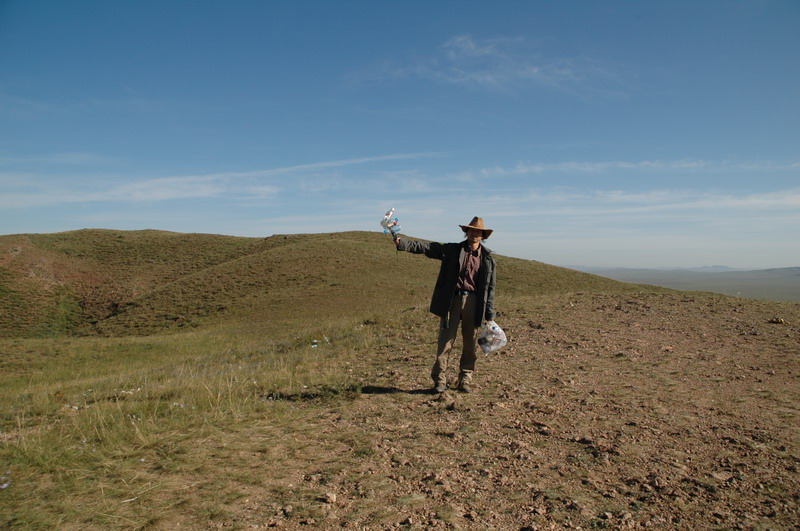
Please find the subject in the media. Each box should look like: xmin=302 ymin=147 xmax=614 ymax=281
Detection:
xmin=394 ymin=216 xmax=496 ymax=393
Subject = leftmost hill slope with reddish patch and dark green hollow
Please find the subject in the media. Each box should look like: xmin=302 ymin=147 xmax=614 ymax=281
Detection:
xmin=0 ymin=230 xmax=251 ymax=337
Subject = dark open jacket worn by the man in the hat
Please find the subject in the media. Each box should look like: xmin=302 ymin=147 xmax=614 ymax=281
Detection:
xmin=397 ymin=239 xmax=496 ymax=326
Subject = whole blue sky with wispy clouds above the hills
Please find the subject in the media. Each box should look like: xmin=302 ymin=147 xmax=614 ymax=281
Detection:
xmin=0 ymin=0 xmax=800 ymax=268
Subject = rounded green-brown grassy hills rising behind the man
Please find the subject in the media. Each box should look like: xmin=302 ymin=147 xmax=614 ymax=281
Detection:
xmin=0 ymin=230 xmax=631 ymax=337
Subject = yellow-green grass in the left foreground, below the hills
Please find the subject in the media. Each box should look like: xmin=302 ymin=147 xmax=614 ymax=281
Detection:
xmin=0 ymin=318 xmax=382 ymax=528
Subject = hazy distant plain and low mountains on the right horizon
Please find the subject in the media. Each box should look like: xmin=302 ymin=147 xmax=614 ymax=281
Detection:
xmin=571 ymin=266 xmax=800 ymax=302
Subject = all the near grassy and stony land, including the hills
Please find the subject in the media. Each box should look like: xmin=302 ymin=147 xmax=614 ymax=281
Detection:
xmin=0 ymin=231 xmax=800 ymax=529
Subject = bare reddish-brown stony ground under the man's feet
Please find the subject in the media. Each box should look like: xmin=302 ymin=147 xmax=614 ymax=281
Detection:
xmin=183 ymin=293 xmax=800 ymax=530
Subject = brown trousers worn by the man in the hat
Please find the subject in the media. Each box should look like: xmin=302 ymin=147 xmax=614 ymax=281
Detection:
xmin=431 ymin=293 xmax=477 ymax=384
